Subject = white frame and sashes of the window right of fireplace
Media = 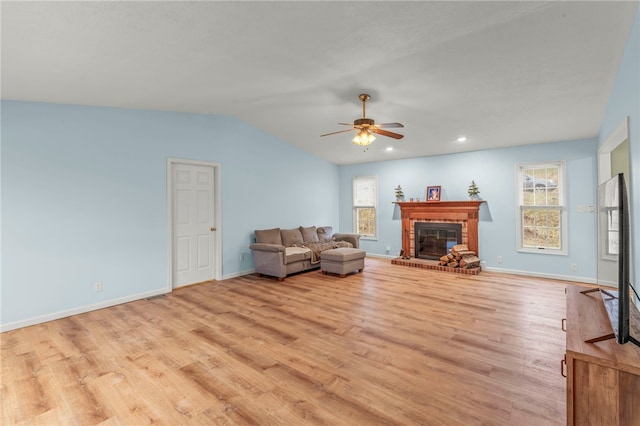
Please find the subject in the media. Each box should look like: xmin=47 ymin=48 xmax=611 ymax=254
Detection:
xmin=515 ymin=160 xmax=569 ymax=255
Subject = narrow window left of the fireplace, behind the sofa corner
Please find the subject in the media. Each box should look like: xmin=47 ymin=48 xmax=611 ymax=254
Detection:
xmin=353 ymin=176 xmax=378 ymax=239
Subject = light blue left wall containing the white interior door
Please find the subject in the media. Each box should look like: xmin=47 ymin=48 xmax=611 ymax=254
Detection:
xmin=0 ymin=101 xmax=338 ymax=329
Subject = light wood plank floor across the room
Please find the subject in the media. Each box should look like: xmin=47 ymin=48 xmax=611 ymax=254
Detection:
xmin=0 ymin=258 xmax=580 ymax=426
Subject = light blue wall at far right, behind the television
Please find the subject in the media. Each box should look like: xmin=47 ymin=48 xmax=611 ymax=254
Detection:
xmin=599 ymin=11 xmax=640 ymax=290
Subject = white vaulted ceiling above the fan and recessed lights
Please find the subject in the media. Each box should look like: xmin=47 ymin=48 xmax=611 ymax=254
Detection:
xmin=0 ymin=1 xmax=638 ymax=164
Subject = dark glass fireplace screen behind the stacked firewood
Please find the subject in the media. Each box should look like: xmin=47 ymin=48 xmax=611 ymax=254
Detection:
xmin=414 ymin=222 xmax=462 ymax=259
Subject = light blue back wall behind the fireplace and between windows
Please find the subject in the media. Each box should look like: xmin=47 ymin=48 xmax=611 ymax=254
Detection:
xmin=340 ymin=139 xmax=597 ymax=282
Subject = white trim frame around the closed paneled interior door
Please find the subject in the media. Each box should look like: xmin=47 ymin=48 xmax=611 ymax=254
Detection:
xmin=167 ymin=157 xmax=222 ymax=292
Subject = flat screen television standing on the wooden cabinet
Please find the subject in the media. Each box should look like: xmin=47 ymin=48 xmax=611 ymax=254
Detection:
xmin=590 ymin=173 xmax=640 ymax=346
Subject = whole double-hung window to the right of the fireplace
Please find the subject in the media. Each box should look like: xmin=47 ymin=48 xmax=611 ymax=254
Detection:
xmin=517 ymin=161 xmax=567 ymax=254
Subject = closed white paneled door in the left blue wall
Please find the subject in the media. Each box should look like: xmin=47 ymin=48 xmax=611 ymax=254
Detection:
xmin=171 ymin=164 xmax=216 ymax=288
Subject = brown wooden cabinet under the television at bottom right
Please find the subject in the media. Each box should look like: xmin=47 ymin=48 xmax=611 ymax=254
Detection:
xmin=565 ymin=286 xmax=640 ymax=426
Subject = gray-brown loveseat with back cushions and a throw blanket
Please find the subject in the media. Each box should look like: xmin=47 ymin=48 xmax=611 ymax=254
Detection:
xmin=250 ymin=226 xmax=360 ymax=281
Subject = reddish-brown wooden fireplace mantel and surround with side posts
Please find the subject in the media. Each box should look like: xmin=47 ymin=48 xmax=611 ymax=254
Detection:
xmin=395 ymin=201 xmax=484 ymax=256
